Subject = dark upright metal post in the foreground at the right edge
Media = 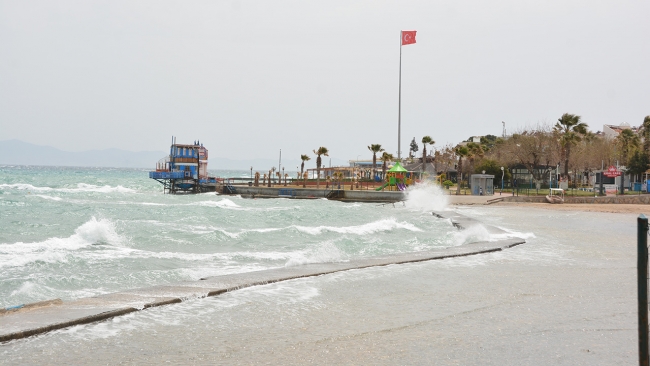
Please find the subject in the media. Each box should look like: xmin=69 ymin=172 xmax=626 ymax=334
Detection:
xmin=636 ymin=214 xmax=649 ymax=366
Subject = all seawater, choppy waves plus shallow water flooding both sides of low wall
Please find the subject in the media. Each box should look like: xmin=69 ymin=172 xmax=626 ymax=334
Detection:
xmin=0 ymin=165 xmax=636 ymax=365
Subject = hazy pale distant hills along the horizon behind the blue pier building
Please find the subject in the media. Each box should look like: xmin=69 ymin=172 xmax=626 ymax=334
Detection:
xmin=0 ymin=140 xmax=348 ymax=171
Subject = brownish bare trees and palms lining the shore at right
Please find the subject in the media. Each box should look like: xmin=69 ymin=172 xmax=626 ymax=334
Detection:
xmin=436 ymin=113 xmax=650 ymax=187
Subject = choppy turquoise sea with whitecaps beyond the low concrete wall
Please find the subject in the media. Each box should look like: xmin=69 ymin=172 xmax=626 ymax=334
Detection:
xmin=0 ymin=166 xmax=466 ymax=307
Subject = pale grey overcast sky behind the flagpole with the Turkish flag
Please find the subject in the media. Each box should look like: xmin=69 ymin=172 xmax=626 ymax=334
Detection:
xmin=0 ymin=0 xmax=650 ymax=160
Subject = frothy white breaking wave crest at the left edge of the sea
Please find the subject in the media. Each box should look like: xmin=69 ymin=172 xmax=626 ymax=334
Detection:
xmin=0 ymin=217 xmax=124 ymax=268
